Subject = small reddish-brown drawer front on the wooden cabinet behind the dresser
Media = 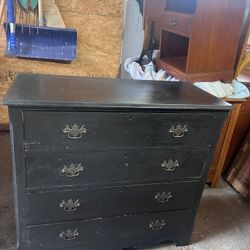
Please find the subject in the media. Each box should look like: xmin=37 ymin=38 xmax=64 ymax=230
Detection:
xmin=162 ymin=11 xmax=192 ymax=36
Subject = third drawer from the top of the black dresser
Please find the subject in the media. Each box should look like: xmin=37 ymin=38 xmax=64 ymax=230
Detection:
xmin=28 ymin=182 xmax=199 ymax=225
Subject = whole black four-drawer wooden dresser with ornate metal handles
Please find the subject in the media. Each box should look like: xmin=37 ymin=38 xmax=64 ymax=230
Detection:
xmin=4 ymin=74 xmax=231 ymax=250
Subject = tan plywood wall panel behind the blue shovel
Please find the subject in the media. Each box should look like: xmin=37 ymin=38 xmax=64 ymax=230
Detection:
xmin=0 ymin=0 xmax=124 ymax=79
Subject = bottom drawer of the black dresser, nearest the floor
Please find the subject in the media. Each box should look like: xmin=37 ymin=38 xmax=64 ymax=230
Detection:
xmin=28 ymin=210 xmax=191 ymax=250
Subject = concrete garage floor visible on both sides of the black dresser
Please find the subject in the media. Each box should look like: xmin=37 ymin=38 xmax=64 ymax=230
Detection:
xmin=0 ymin=132 xmax=250 ymax=250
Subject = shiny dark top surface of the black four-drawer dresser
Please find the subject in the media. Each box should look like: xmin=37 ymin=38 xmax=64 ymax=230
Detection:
xmin=3 ymin=74 xmax=232 ymax=110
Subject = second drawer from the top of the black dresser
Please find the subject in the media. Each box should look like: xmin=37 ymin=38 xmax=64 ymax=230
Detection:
xmin=26 ymin=147 xmax=208 ymax=189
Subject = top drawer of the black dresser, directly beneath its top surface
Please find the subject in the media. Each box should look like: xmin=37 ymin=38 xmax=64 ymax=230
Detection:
xmin=24 ymin=111 xmax=216 ymax=151
